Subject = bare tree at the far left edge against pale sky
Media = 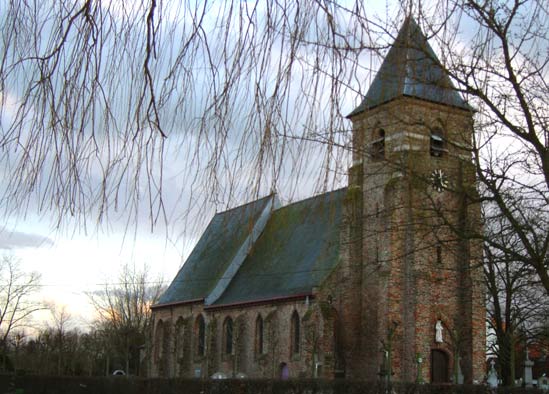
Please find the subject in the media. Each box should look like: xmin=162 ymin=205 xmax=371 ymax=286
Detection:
xmin=0 ymin=255 xmax=43 ymax=370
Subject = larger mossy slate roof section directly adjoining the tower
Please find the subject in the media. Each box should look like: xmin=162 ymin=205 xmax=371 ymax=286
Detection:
xmin=214 ymin=189 xmax=347 ymax=305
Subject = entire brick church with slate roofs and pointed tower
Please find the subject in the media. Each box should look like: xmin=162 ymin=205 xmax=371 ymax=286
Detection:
xmin=150 ymin=17 xmax=486 ymax=383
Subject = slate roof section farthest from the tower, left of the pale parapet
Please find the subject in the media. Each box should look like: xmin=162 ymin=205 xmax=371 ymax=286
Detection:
xmin=158 ymin=195 xmax=275 ymax=305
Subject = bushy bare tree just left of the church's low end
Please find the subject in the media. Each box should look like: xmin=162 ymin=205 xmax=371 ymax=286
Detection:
xmin=89 ymin=265 xmax=163 ymax=373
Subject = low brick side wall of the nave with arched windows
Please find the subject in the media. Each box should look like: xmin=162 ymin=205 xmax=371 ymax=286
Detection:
xmin=151 ymin=297 xmax=335 ymax=378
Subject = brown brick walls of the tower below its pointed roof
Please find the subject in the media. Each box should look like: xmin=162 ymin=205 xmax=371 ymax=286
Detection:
xmin=343 ymin=98 xmax=485 ymax=382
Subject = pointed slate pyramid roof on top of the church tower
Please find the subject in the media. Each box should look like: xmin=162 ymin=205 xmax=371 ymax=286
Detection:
xmin=347 ymin=17 xmax=471 ymax=118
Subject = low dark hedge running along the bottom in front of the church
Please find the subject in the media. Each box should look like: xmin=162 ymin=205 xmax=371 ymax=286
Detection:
xmin=0 ymin=375 xmax=540 ymax=394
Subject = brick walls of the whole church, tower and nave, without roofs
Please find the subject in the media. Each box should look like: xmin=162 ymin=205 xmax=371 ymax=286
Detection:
xmin=151 ymin=97 xmax=485 ymax=383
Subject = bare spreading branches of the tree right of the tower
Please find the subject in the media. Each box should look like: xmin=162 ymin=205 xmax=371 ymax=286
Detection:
xmin=434 ymin=0 xmax=549 ymax=294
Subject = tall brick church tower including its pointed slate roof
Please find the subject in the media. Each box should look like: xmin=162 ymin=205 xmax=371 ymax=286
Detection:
xmin=340 ymin=17 xmax=485 ymax=383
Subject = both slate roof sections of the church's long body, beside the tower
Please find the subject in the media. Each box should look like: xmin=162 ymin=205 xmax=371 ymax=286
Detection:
xmin=156 ymin=189 xmax=346 ymax=307
